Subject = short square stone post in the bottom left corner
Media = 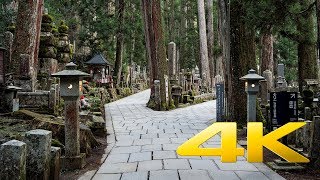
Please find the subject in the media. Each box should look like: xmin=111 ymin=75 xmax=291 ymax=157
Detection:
xmin=0 ymin=140 xmax=27 ymax=180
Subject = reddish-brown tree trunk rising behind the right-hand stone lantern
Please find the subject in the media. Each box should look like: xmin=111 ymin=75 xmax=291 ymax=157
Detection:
xmin=261 ymin=27 xmax=274 ymax=73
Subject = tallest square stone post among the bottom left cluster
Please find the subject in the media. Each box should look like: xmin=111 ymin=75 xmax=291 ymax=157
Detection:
xmin=25 ymin=129 xmax=52 ymax=180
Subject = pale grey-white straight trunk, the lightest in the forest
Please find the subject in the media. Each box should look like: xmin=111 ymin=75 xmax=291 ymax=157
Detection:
xmin=198 ymin=0 xmax=210 ymax=87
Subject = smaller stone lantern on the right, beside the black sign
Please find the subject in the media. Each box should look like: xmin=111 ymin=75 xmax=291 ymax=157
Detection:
xmin=240 ymin=69 xmax=265 ymax=122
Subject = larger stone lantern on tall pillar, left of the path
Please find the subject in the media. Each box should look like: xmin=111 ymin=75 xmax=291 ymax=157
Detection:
xmin=52 ymin=62 xmax=90 ymax=170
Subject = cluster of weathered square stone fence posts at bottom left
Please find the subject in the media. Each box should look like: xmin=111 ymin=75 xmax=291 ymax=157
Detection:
xmin=0 ymin=129 xmax=61 ymax=180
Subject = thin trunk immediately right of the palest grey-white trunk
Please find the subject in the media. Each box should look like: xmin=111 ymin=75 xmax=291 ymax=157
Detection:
xmin=207 ymin=0 xmax=216 ymax=88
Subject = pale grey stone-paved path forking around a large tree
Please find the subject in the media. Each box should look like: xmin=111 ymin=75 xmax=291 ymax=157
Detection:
xmin=89 ymin=90 xmax=283 ymax=180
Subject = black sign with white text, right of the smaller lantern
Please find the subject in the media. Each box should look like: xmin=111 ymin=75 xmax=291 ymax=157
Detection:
xmin=270 ymin=92 xmax=298 ymax=130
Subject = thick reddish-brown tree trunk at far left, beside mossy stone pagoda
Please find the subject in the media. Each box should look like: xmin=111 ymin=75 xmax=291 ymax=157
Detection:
xmin=12 ymin=0 xmax=43 ymax=91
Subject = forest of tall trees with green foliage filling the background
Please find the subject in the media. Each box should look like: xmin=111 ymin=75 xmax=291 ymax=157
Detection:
xmin=0 ymin=0 xmax=320 ymax=123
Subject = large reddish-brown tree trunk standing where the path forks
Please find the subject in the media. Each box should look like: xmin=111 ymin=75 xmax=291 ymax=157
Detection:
xmin=142 ymin=0 xmax=170 ymax=110
